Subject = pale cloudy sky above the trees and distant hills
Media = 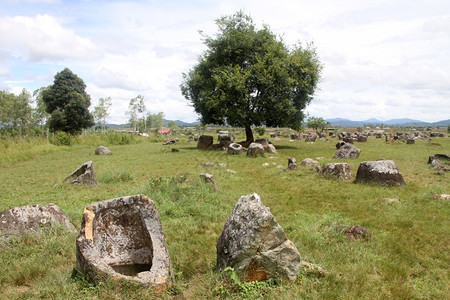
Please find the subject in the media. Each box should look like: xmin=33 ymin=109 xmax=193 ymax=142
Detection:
xmin=0 ymin=0 xmax=450 ymax=123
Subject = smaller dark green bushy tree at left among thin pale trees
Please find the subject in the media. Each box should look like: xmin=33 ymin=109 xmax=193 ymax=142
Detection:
xmin=42 ymin=68 xmax=94 ymax=134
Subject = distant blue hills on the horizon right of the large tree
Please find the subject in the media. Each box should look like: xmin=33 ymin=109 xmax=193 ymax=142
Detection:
xmin=326 ymin=118 xmax=450 ymax=127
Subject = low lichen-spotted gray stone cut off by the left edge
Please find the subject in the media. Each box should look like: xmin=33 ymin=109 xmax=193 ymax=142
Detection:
xmin=0 ymin=203 xmax=75 ymax=241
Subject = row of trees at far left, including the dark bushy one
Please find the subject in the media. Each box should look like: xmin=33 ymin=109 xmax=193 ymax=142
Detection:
xmin=0 ymin=68 xmax=112 ymax=138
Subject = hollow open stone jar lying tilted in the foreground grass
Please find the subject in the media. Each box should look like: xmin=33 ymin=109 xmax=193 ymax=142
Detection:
xmin=76 ymin=195 xmax=172 ymax=291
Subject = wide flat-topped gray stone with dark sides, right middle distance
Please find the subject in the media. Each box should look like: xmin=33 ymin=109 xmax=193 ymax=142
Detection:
xmin=355 ymin=160 xmax=405 ymax=186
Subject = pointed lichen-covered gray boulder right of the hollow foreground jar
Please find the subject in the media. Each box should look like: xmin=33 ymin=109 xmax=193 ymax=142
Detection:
xmin=217 ymin=193 xmax=301 ymax=281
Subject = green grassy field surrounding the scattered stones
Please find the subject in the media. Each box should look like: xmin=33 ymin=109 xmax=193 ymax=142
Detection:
xmin=0 ymin=134 xmax=450 ymax=299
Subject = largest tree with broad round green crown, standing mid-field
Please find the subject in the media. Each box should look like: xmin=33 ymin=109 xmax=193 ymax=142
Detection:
xmin=180 ymin=12 xmax=322 ymax=145
